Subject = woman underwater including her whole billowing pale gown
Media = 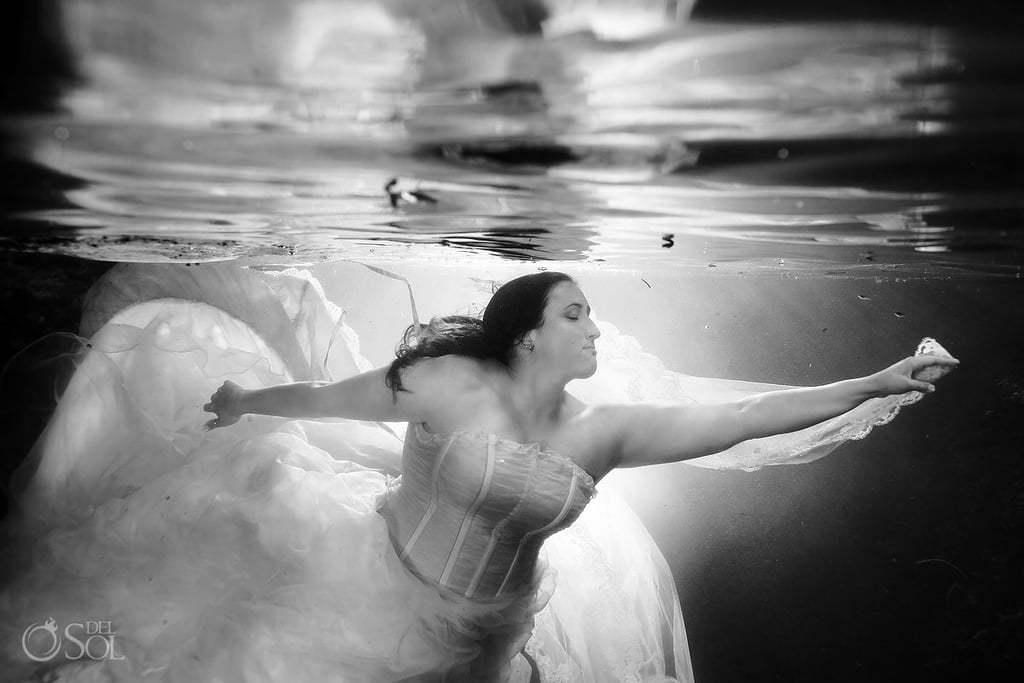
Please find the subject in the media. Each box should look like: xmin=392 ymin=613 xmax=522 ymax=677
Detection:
xmin=0 ymin=269 xmax=957 ymax=682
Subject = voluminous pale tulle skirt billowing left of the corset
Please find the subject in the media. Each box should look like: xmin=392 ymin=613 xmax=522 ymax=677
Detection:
xmin=0 ymin=301 xmax=546 ymax=681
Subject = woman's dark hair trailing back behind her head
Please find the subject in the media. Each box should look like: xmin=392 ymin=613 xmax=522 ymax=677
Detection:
xmin=384 ymin=271 xmax=575 ymax=396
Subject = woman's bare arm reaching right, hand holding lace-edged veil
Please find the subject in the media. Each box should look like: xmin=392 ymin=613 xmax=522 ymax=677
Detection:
xmin=602 ymin=355 xmax=959 ymax=467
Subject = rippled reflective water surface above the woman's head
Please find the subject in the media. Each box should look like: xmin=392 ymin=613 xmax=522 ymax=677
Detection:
xmin=4 ymin=15 xmax=1024 ymax=276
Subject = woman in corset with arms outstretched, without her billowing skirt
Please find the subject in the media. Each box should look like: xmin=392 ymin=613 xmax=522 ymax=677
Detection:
xmin=206 ymin=272 xmax=956 ymax=681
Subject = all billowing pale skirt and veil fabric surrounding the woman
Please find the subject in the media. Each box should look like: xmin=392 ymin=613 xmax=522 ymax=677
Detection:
xmin=0 ymin=265 xmax=946 ymax=683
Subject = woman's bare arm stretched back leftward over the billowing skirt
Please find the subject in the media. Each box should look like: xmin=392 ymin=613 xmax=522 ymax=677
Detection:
xmin=203 ymin=358 xmax=445 ymax=429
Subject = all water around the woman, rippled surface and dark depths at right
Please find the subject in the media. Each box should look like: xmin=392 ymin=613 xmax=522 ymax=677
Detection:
xmin=0 ymin=0 xmax=1024 ymax=682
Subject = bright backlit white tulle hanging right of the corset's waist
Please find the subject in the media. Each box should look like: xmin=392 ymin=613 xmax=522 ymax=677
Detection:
xmin=526 ymin=487 xmax=693 ymax=683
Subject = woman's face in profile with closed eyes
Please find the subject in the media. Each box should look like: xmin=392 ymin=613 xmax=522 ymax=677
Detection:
xmin=527 ymin=282 xmax=601 ymax=379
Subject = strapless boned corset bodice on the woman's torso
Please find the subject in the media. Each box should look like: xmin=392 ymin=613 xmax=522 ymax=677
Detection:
xmin=381 ymin=424 xmax=595 ymax=598
